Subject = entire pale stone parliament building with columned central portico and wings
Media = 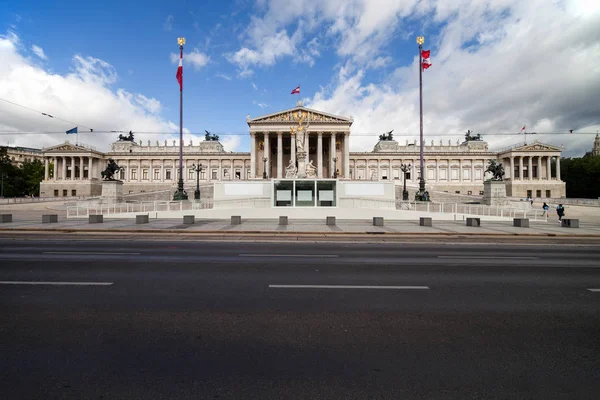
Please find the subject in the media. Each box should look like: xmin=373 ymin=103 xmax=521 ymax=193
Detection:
xmin=41 ymin=105 xmax=565 ymax=200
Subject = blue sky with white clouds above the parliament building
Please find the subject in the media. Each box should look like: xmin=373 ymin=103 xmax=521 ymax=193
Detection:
xmin=0 ymin=0 xmax=600 ymax=155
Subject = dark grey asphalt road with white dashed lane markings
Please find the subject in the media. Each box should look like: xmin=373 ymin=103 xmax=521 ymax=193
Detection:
xmin=0 ymin=239 xmax=600 ymax=399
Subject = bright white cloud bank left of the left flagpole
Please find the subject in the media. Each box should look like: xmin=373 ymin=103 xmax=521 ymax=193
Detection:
xmin=0 ymin=30 xmax=179 ymax=150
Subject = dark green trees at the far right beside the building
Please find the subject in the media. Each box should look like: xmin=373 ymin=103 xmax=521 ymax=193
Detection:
xmin=560 ymin=156 xmax=600 ymax=199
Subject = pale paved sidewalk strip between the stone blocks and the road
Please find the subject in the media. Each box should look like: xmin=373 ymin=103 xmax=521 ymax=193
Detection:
xmin=0 ymin=216 xmax=600 ymax=237
